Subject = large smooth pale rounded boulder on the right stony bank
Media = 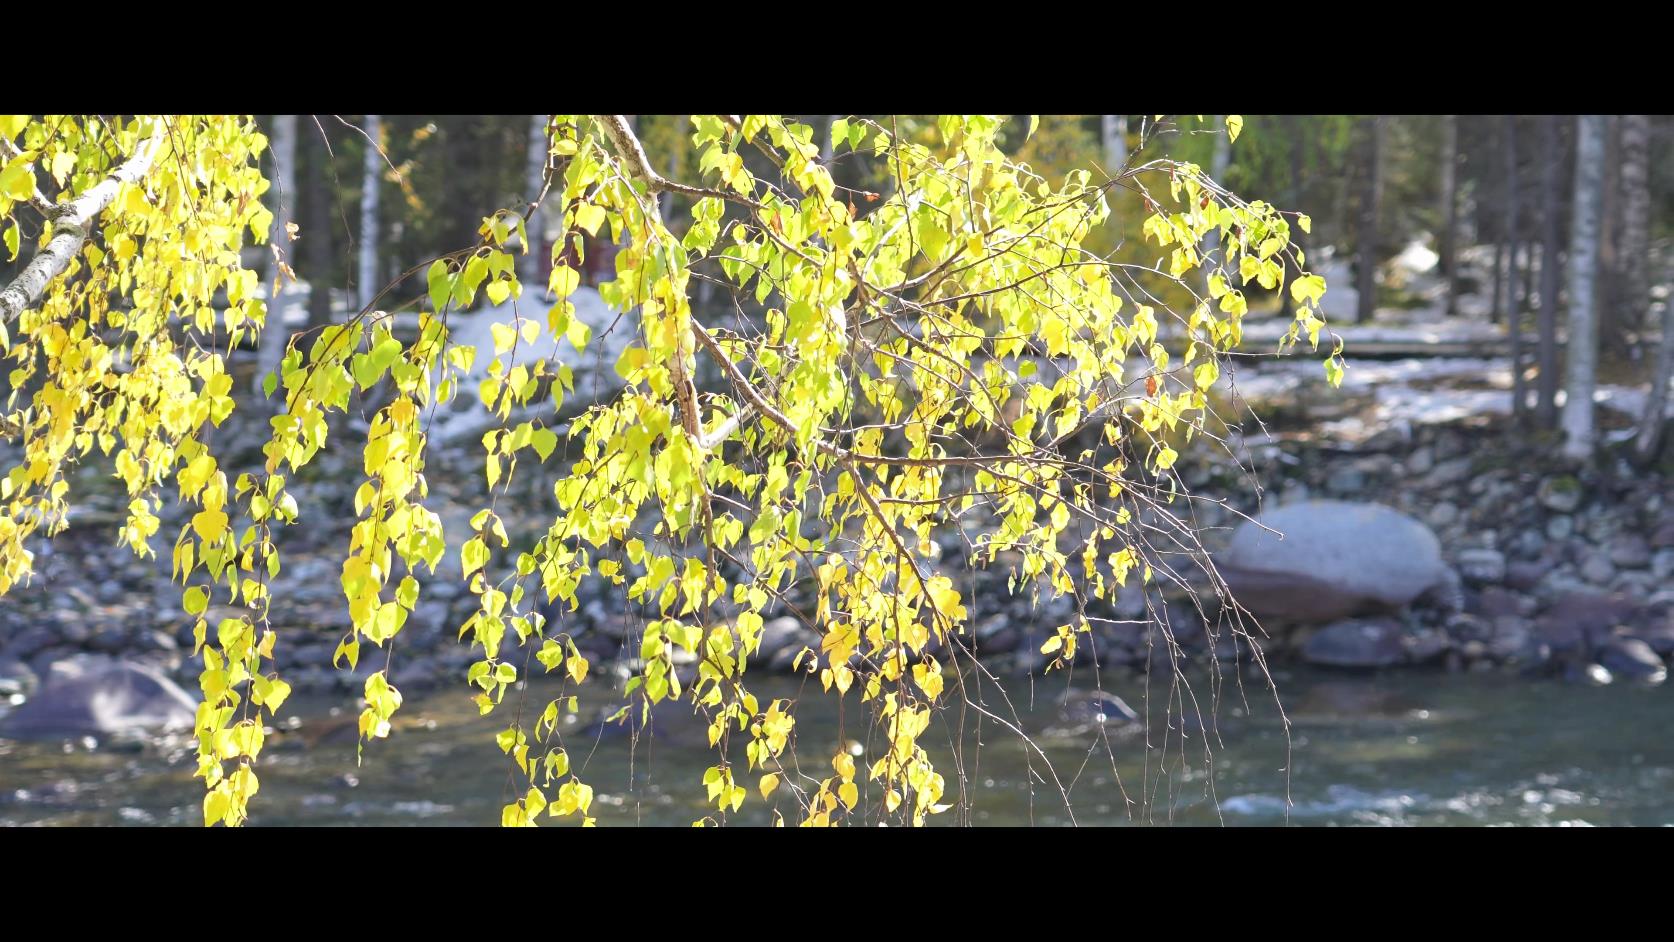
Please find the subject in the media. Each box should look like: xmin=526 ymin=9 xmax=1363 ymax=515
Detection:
xmin=1215 ymin=500 xmax=1461 ymax=622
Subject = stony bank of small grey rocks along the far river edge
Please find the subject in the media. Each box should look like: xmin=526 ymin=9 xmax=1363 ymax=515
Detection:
xmin=0 ymin=398 xmax=1674 ymax=716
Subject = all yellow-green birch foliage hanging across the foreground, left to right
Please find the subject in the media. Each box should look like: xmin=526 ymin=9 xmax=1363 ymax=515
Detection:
xmin=0 ymin=115 xmax=1341 ymax=825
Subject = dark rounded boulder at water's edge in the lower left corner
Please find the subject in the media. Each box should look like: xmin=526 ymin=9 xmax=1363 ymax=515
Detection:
xmin=0 ymin=661 xmax=198 ymax=740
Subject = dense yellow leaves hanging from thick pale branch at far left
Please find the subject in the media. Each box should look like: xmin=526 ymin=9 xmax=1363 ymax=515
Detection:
xmin=0 ymin=115 xmax=281 ymax=823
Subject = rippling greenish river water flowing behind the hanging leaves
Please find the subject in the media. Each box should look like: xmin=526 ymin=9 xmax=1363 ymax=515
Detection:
xmin=0 ymin=669 xmax=1674 ymax=827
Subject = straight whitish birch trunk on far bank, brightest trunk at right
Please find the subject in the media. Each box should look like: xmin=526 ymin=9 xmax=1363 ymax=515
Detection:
xmin=1564 ymin=114 xmax=1605 ymax=460
